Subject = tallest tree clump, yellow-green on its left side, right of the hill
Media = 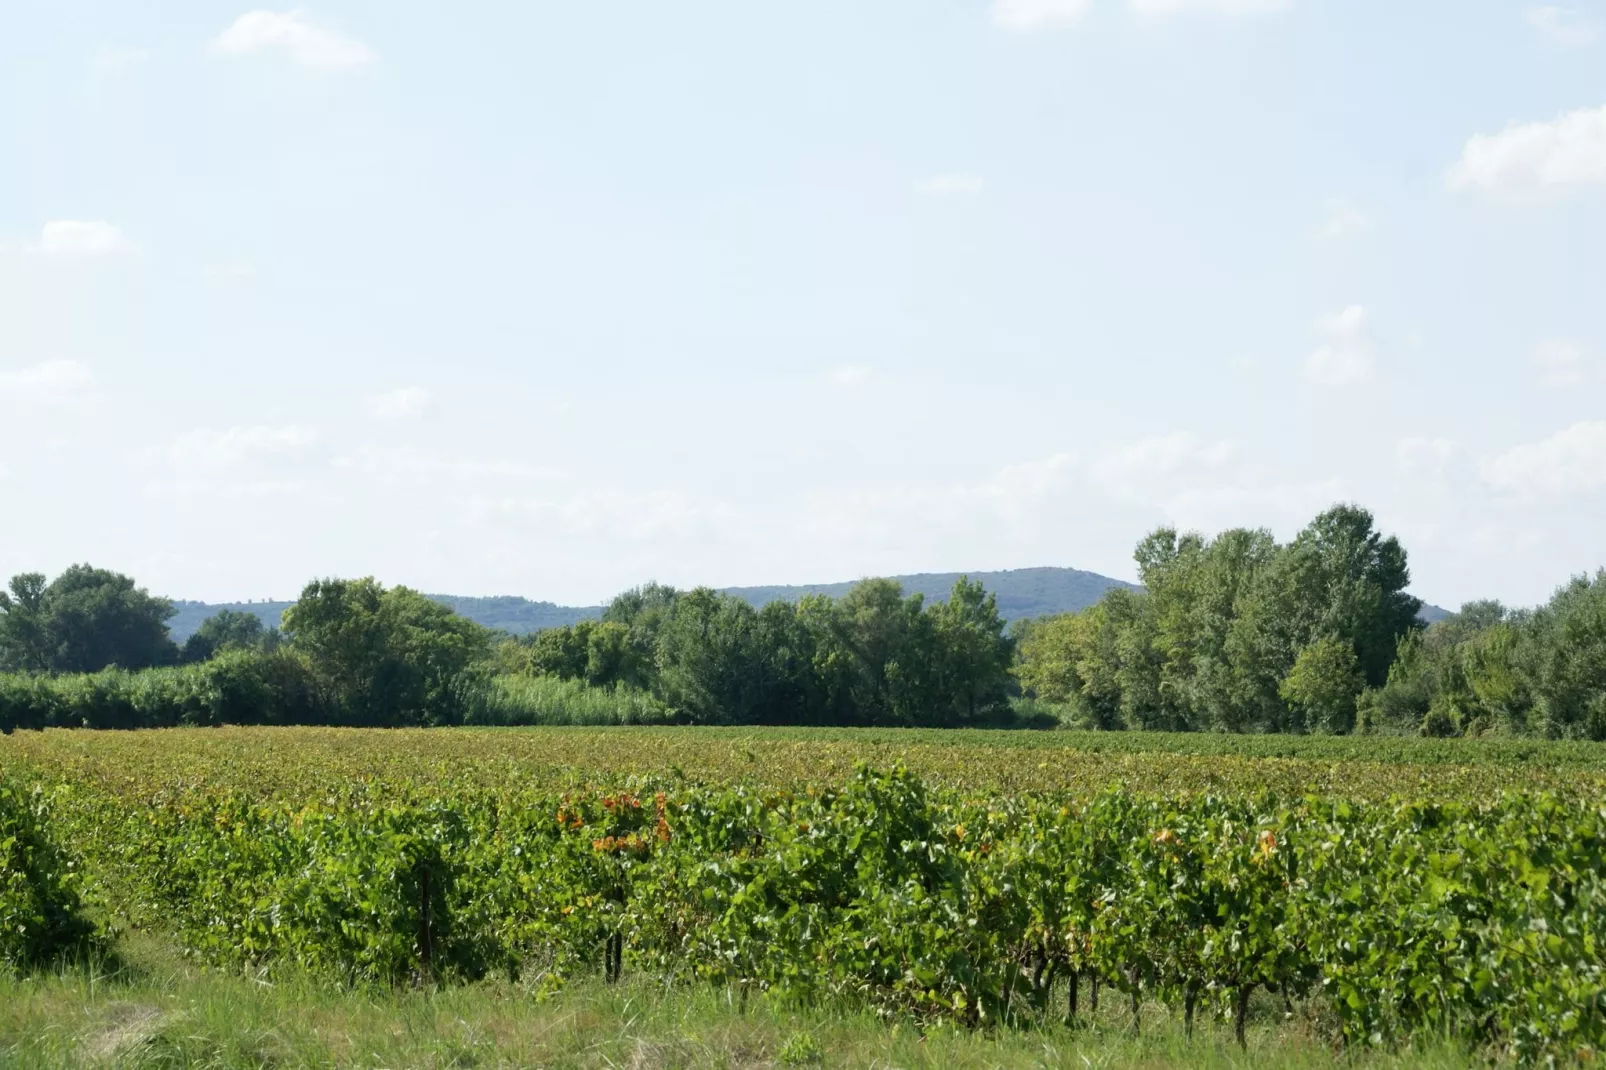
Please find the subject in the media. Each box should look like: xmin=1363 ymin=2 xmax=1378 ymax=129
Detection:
xmin=1017 ymin=506 xmax=1421 ymax=733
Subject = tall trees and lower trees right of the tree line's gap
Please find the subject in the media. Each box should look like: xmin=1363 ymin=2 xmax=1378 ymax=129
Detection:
xmin=1017 ymin=506 xmax=1606 ymax=739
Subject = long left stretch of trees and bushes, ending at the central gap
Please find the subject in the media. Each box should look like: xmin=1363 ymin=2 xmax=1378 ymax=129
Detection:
xmin=0 ymin=566 xmax=1015 ymax=726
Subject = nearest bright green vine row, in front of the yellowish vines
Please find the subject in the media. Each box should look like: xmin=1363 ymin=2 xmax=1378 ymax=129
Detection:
xmin=25 ymin=758 xmax=1606 ymax=1059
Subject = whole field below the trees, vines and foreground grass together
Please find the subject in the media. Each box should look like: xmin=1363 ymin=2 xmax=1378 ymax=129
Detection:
xmin=0 ymin=728 xmax=1606 ymax=1067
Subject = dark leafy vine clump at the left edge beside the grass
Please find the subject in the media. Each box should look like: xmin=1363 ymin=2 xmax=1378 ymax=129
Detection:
xmin=0 ymin=776 xmax=93 ymax=967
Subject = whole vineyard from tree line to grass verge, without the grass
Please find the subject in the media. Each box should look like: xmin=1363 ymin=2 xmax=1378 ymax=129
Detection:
xmin=0 ymin=719 xmax=1606 ymax=1062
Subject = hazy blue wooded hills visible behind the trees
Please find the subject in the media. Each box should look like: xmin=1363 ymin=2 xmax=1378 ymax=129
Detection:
xmin=167 ymin=569 xmax=1450 ymax=643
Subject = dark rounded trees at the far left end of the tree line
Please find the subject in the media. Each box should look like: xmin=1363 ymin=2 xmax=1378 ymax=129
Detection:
xmin=0 ymin=564 xmax=178 ymax=673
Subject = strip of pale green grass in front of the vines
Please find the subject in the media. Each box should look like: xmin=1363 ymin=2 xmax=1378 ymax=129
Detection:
xmin=0 ymin=940 xmax=1479 ymax=1070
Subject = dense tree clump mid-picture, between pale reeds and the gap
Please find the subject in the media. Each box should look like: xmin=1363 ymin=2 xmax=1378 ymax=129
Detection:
xmin=498 ymin=578 xmax=1013 ymax=725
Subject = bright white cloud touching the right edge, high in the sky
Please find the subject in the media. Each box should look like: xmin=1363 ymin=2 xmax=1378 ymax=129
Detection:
xmin=1447 ymin=106 xmax=1606 ymax=198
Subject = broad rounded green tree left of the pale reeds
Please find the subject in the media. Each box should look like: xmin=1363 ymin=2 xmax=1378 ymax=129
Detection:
xmin=284 ymin=578 xmax=490 ymax=725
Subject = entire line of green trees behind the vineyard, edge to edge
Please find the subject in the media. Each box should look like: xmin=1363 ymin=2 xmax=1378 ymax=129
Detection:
xmin=0 ymin=504 xmax=1606 ymax=739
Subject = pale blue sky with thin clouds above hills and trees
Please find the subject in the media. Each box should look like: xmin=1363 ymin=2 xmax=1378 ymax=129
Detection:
xmin=0 ymin=0 xmax=1606 ymax=606
